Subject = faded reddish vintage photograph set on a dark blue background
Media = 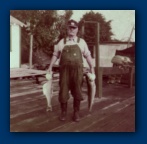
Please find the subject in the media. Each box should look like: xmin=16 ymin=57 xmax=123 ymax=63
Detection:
xmin=10 ymin=10 xmax=135 ymax=132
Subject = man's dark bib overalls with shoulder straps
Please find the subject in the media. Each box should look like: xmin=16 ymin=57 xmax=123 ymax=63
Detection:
xmin=59 ymin=38 xmax=83 ymax=103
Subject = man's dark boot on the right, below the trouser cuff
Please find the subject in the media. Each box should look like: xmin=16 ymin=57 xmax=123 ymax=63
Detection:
xmin=73 ymin=100 xmax=80 ymax=122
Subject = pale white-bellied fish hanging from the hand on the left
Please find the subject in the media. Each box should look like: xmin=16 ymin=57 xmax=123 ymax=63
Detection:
xmin=42 ymin=72 xmax=53 ymax=111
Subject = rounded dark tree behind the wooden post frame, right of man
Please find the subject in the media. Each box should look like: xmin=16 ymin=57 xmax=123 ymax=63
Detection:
xmin=79 ymin=11 xmax=113 ymax=42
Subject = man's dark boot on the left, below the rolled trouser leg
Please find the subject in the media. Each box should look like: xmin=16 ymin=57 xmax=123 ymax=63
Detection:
xmin=59 ymin=103 xmax=67 ymax=121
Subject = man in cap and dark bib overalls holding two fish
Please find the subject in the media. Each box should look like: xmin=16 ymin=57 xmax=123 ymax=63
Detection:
xmin=48 ymin=20 xmax=94 ymax=122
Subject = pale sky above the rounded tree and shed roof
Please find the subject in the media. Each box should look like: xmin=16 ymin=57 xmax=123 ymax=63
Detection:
xmin=71 ymin=10 xmax=135 ymax=41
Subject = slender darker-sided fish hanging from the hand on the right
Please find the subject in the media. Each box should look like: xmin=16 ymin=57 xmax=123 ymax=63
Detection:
xmin=87 ymin=73 xmax=96 ymax=112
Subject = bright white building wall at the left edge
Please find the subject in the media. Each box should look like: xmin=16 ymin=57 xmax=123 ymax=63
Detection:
xmin=10 ymin=25 xmax=21 ymax=68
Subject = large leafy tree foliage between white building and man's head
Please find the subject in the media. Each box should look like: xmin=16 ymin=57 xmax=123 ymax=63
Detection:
xmin=10 ymin=10 xmax=72 ymax=55
